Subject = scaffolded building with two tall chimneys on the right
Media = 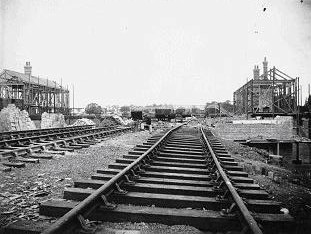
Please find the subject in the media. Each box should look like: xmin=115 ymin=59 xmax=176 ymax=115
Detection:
xmin=233 ymin=58 xmax=299 ymax=117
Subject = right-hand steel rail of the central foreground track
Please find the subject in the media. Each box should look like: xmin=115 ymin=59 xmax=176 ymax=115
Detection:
xmin=201 ymin=127 xmax=262 ymax=234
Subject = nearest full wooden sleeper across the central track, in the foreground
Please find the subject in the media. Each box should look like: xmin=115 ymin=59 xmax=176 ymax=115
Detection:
xmin=40 ymin=201 xmax=295 ymax=233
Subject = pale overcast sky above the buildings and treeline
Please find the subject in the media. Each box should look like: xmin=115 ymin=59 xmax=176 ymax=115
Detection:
xmin=0 ymin=0 xmax=311 ymax=107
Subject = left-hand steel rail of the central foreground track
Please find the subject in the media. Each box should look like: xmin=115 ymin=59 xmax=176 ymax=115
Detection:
xmin=42 ymin=123 xmax=187 ymax=234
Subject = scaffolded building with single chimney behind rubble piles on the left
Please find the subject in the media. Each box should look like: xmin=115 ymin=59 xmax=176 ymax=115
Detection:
xmin=0 ymin=62 xmax=69 ymax=118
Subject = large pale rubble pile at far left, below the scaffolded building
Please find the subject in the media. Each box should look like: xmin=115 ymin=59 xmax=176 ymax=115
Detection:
xmin=0 ymin=104 xmax=36 ymax=132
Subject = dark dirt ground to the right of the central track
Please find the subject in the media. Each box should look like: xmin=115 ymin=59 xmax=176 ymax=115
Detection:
xmin=221 ymin=140 xmax=311 ymax=222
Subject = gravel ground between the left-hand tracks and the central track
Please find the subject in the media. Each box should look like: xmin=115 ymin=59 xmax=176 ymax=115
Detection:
xmin=0 ymin=131 xmax=154 ymax=227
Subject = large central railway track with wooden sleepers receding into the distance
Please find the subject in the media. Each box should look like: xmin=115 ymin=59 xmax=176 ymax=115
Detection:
xmin=3 ymin=124 xmax=294 ymax=234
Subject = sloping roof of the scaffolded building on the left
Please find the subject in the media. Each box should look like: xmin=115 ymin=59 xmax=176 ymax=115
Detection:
xmin=0 ymin=69 xmax=64 ymax=89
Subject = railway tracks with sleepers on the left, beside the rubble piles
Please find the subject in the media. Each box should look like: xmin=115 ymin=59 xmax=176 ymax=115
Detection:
xmin=0 ymin=125 xmax=131 ymax=171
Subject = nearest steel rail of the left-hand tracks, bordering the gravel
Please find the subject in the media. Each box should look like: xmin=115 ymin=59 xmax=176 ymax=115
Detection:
xmin=0 ymin=127 xmax=131 ymax=157
